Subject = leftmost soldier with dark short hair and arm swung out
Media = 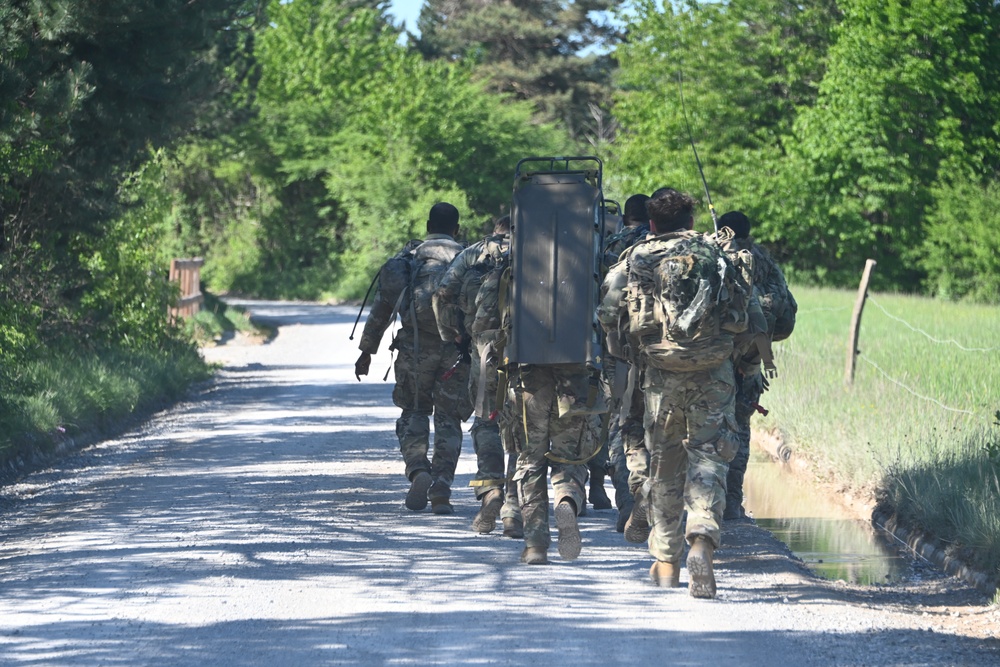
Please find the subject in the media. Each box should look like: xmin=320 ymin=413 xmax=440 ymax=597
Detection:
xmin=354 ymin=202 xmax=472 ymax=514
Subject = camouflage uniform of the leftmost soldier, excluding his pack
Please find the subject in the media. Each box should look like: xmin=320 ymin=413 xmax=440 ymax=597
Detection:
xmin=358 ymin=234 xmax=472 ymax=500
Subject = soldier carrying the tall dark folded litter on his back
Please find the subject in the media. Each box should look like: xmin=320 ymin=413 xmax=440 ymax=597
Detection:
xmin=508 ymin=157 xmax=604 ymax=565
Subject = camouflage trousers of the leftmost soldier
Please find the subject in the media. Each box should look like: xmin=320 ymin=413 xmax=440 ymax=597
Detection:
xmin=392 ymin=328 xmax=472 ymax=499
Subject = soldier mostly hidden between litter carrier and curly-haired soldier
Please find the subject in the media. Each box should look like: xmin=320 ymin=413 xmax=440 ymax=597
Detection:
xmin=604 ymin=194 xmax=649 ymax=542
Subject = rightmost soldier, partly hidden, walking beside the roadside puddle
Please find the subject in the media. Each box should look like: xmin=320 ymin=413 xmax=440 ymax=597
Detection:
xmin=719 ymin=211 xmax=798 ymax=520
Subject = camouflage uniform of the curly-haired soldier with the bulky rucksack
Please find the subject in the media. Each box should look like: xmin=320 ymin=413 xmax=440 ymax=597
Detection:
xmin=598 ymin=232 xmax=746 ymax=563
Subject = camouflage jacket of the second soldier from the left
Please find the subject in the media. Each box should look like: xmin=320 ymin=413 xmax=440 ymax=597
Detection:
xmin=434 ymin=234 xmax=510 ymax=342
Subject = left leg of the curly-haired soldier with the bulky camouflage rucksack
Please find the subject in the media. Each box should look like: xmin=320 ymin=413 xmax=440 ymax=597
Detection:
xmin=645 ymin=369 xmax=687 ymax=563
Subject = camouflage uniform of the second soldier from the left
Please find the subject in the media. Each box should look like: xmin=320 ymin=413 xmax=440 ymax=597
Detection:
xmin=434 ymin=235 xmax=520 ymax=506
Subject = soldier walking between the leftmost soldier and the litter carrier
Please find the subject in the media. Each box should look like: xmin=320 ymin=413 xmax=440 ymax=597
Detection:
xmin=434 ymin=216 xmax=524 ymax=539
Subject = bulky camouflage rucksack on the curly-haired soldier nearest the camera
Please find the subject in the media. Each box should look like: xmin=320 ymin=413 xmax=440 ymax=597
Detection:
xmin=626 ymin=232 xmax=749 ymax=371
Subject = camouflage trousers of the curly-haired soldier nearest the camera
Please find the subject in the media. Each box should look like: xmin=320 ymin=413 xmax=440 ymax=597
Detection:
xmin=643 ymin=360 xmax=738 ymax=562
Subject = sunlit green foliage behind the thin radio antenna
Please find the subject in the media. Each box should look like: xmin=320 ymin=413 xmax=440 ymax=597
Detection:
xmin=612 ymin=0 xmax=838 ymax=237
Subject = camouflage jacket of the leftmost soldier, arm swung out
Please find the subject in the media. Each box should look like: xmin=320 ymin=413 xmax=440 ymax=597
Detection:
xmin=358 ymin=234 xmax=462 ymax=354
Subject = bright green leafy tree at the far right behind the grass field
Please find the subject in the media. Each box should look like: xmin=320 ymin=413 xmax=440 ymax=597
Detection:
xmin=794 ymin=0 xmax=1000 ymax=290
